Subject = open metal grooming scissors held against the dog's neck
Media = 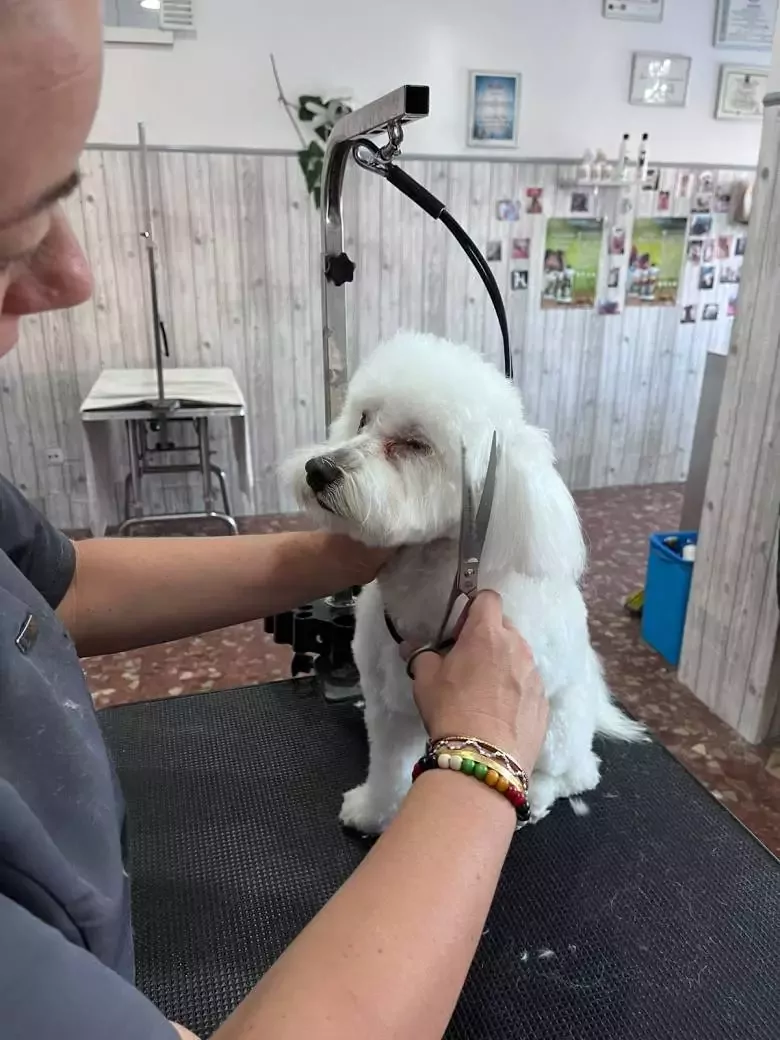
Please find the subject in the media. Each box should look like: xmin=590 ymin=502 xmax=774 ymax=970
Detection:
xmin=407 ymin=431 xmax=498 ymax=678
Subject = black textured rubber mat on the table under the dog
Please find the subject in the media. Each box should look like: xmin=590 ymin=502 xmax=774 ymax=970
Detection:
xmin=101 ymin=680 xmax=780 ymax=1040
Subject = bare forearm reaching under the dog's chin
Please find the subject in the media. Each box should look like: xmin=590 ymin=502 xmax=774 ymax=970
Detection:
xmin=57 ymin=531 xmax=376 ymax=656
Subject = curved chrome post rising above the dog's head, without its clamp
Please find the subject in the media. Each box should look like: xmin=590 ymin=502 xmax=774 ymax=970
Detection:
xmin=320 ymin=85 xmax=430 ymax=426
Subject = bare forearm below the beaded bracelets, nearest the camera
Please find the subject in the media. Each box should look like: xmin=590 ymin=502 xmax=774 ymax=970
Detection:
xmin=213 ymin=771 xmax=516 ymax=1040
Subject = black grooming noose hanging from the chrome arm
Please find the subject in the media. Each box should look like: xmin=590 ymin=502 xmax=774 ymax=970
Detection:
xmin=353 ymin=138 xmax=513 ymax=380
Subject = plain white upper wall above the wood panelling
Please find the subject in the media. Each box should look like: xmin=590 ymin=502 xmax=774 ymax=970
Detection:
xmin=93 ymin=0 xmax=770 ymax=164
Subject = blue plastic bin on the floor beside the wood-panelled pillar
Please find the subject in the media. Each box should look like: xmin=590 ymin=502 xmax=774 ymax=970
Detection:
xmin=642 ymin=530 xmax=697 ymax=668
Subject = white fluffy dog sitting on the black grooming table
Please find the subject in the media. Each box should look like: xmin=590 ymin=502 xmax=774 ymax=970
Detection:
xmin=286 ymin=333 xmax=643 ymax=834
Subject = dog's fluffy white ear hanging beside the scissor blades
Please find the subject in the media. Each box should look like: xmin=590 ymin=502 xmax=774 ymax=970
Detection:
xmin=486 ymin=423 xmax=586 ymax=581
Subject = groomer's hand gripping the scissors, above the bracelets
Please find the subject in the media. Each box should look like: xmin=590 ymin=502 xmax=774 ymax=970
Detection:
xmin=413 ymin=592 xmax=547 ymax=773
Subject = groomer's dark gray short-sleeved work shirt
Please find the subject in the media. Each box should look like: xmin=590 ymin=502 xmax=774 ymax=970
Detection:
xmin=0 ymin=477 xmax=176 ymax=1040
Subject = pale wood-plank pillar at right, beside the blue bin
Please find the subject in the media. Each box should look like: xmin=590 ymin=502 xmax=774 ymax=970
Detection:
xmin=680 ymin=107 xmax=780 ymax=743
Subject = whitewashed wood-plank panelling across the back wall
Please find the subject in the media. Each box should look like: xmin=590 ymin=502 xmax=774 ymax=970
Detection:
xmin=0 ymin=149 xmax=752 ymax=528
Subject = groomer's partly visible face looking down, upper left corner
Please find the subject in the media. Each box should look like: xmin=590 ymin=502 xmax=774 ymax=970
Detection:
xmin=0 ymin=0 xmax=102 ymax=355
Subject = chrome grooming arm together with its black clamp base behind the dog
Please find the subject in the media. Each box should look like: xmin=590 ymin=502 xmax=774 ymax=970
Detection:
xmin=265 ymin=85 xmax=431 ymax=701
